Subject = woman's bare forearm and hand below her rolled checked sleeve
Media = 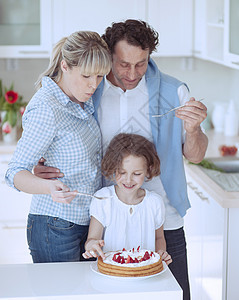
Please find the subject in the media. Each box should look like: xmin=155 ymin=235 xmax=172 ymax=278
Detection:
xmin=13 ymin=170 xmax=77 ymax=203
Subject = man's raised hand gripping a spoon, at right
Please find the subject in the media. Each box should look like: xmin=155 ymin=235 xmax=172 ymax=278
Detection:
xmin=175 ymin=97 xmax=207 ymax=134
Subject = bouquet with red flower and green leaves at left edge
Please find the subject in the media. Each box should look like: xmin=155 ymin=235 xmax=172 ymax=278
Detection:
xmin=0 ymin=80 xmax=27 ymax=134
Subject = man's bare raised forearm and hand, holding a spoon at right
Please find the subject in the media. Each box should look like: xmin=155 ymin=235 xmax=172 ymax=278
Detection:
xmin=175 ymin=98 xmax=208 ymax=163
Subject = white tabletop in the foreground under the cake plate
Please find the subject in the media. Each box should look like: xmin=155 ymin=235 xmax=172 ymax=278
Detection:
xmin=0 ymin=262 xmax=182 ymax=300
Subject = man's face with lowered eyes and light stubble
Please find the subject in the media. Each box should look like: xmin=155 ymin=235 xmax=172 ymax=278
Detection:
xmin=107 ymin=40 xmax=149 ymax=91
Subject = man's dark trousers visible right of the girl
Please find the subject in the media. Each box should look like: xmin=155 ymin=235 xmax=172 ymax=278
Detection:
xmin=164 ymin=227 xmax=190 ymax=300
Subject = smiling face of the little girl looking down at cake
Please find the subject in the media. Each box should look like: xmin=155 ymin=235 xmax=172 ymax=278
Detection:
xmin=115 ymin=155 xmax=147 ymax=193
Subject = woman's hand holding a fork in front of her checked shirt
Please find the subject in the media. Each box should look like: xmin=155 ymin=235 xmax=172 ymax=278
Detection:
xmin=49 ymin=180 xmax=77 ymax=204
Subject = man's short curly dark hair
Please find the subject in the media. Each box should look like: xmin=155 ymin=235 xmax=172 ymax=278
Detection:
xmin=102 ymin=19 xmax=159 ymax=55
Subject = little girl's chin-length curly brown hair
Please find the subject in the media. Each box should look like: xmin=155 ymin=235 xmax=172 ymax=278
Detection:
xmin=101 ymin=133 xmax=160 ymax=180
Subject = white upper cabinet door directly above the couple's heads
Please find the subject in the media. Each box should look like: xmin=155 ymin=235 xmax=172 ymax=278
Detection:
xmin=53 ymin=0 xmax=145 ymax=43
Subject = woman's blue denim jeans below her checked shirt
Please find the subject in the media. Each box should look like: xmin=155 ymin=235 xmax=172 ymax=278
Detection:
xmin=27 ymin=214 xmax=89 ymax=263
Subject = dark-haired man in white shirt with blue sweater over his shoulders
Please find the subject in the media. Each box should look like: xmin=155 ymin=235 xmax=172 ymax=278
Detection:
xmin=35 ymin=20 xmax=208 ymax=299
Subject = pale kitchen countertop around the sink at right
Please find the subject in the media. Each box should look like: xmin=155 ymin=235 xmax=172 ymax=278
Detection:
xmin=185 ymin=130 xmax=239 ymax=208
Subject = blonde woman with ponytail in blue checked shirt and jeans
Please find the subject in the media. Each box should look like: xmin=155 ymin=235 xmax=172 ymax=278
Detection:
xmin=6 ymin=32 xmax=111 ymax=263
